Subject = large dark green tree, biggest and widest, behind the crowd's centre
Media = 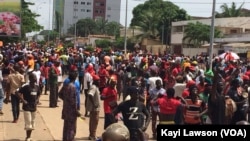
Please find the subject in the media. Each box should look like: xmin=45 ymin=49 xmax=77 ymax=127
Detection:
xmin=131 ymin=0 xmax=190 ymax=44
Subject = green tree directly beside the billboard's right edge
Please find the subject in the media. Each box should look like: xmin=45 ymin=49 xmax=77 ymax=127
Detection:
xmin=21 ymin=0 xmax=43 ymax=39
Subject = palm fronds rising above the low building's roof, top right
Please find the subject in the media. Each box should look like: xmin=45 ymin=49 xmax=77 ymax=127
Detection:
xmin=215 ymin=2 xmax=244 ymax=18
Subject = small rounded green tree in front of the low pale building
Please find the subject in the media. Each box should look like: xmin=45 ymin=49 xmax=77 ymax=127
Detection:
xmin=183 ymin=22 xmax=222 ymax=47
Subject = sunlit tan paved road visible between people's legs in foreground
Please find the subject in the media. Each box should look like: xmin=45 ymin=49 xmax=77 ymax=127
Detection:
xmin=0 ymin=78 xmax=156 ymax=141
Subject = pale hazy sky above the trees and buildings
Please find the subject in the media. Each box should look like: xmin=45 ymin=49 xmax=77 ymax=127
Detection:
xmin=26 ymin=0 xmax=250 ymax=30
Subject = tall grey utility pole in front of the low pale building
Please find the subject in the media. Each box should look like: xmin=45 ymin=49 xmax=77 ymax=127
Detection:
xmin=209 ymin=0 xmax=216 ymax=70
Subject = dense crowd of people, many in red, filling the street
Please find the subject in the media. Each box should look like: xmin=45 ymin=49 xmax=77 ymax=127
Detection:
xmin=0 ymin=44 xmax=250 ymax=141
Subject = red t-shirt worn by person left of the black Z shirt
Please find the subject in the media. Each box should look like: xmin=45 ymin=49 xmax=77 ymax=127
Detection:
xmin=102 ymin=87 xmax=117 ymax=113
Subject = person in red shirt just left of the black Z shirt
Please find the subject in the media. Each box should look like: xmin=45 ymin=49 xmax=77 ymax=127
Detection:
xmin=101 ymin=79 xmax=118 ymax=129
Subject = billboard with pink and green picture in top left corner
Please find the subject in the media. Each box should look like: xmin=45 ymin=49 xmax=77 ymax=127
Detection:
xmin=0 ymin=0 xmax=21 ymax=37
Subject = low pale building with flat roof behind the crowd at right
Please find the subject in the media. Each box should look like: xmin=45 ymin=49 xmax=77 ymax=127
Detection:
xmin=171 ymin=17 xmax=250 ymax=54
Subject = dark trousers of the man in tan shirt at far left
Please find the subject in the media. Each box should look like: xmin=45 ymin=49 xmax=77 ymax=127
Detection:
xmin=11 ymin=94 xmax=20 ymax=120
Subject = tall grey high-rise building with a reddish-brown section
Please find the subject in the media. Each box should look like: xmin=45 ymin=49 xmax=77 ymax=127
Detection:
xmin=57 ymin=0 xmax=121 ymax=34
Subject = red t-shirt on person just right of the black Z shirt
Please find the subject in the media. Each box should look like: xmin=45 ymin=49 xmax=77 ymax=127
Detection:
xmin=157 ymin=97 xmax=181 ymax=114
